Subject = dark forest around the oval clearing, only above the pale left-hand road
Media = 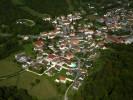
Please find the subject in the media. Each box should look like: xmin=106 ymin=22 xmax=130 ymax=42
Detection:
xmin=0 ymin=0 xmax=53 ymax=35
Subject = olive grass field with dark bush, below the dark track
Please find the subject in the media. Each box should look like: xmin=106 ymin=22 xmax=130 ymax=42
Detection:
xmin=0 ymin=70 xmax=60 ymax=100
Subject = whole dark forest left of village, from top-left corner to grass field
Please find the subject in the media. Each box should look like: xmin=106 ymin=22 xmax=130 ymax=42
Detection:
xmin=0 ymin=0 xmax=54 ymax=59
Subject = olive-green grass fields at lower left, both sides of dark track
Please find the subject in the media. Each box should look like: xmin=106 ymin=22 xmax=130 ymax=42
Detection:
xmin=0 ymin=56 xmax=60 ymax=100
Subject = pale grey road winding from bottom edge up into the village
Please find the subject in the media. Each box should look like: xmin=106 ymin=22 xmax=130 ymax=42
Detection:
xmin=64 ymin=57 xmax=80 ymax=100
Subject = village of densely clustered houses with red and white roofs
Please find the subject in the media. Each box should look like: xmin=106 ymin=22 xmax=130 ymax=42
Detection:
xmin=15 ymin=8 xmax=133 ymax=90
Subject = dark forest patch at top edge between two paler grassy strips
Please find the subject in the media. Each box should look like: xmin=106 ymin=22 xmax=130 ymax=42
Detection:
xmin=23 ymin=0 xmax=68 ymax=16
